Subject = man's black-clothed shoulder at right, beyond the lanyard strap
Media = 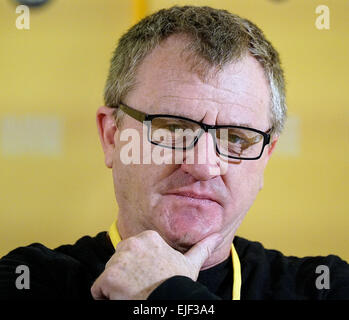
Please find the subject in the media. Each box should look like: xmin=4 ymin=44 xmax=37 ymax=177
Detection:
xmin=234 ymin=237 xmax=349 ymax=300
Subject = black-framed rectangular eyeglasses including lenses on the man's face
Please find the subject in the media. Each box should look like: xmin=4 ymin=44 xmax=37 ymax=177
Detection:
xmin=115 ymin=103 xmax=272 ymax=160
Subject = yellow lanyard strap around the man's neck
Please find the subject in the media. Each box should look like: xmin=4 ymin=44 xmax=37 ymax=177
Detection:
xmin=109 ymin=220 xmax=241 ymax=300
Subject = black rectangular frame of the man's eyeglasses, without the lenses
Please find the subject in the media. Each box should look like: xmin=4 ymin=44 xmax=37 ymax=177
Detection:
xmin=113 ymin=102 xmax=273 ymax=160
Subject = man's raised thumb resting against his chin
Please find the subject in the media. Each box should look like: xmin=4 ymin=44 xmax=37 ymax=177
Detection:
xmin=184 ymin=233 xmax=223 ymax=280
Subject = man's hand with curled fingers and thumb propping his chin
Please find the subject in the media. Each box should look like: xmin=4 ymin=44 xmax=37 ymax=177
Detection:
xmin=91 ymin=230 xmax=222 ymax=300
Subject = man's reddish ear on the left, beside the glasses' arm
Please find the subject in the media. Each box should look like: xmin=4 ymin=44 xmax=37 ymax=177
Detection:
xmin=96 ymin=106 xmax=117 ymax=168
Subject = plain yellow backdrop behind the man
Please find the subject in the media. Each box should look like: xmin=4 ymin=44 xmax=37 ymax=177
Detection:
xmin=0 ymin=0 xmax=349 ymax=260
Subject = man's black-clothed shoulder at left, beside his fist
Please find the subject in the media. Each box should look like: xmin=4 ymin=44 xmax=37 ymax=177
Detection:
xmin=0 ymin=233 xmax=109 ymax=299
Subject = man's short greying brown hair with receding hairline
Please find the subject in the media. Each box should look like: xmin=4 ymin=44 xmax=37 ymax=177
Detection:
xmin=104 ymin=6 xmax=287 ymax=135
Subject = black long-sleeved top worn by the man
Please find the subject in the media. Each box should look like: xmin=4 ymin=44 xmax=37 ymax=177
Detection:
xmin=0 ymin=232 xmax=349 ymax=300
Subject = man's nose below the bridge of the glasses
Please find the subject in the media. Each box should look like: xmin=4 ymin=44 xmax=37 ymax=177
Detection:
xmin=181 ymin=132 xmax=223 ymax=181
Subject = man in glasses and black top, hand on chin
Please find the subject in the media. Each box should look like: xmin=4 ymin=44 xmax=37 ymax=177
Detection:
xmin=0 ymin=6 xmax=349 ymax=300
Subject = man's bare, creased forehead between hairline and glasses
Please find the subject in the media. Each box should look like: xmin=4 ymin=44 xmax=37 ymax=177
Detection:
xmin=128 ymin=36 xmax=270 ymax=127
